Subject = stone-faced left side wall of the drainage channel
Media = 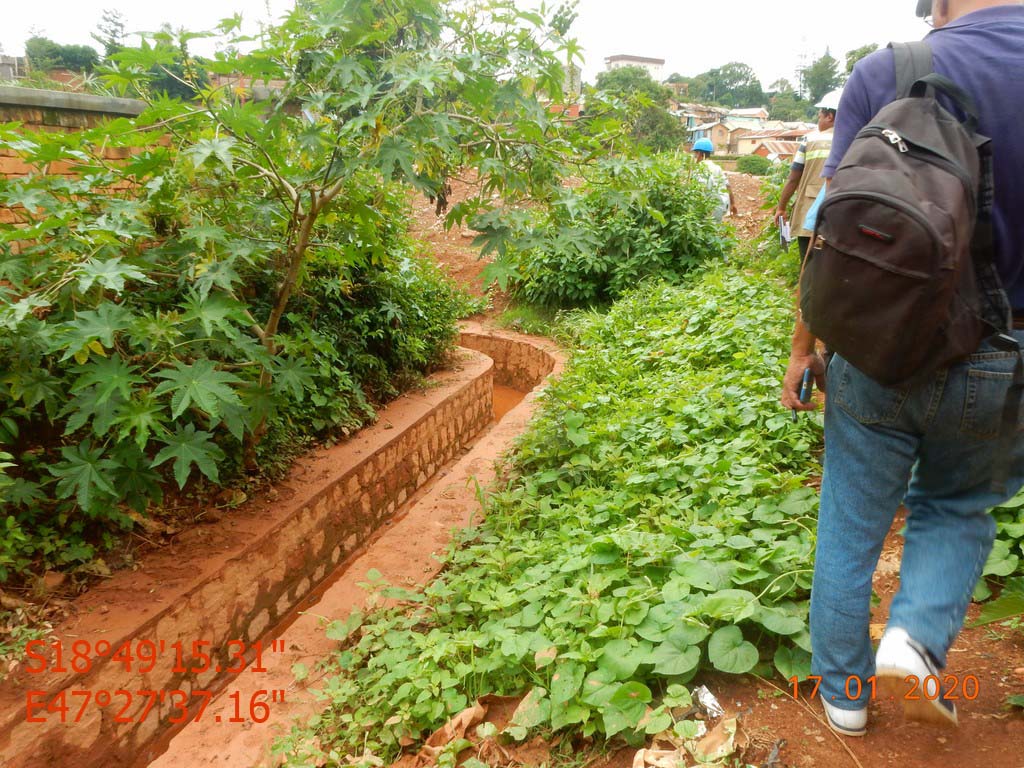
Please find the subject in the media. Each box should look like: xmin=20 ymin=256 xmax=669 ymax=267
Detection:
xmin=0 ymin=351 xmax=494 ymax=768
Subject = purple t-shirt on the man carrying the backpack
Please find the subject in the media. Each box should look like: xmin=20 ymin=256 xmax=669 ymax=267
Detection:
xmin=821 ymin=5 xmax=1024 ymax=310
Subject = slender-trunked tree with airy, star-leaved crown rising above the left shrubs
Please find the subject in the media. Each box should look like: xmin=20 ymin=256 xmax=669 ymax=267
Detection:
xmin=108 ymin=0 xmax=585 ymax=449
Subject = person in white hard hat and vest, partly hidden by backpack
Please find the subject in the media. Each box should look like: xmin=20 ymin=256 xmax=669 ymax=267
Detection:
xmin=775 ymin=88 xmax=843 ymax=257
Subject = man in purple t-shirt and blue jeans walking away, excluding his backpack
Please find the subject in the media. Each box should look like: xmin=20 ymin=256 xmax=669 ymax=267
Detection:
xmin=781 ymin=0 xmax=1024 ymax=736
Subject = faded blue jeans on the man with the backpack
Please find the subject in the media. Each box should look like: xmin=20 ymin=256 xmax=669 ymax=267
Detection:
xmin=810 ymin=331 xmax=1024 ymax=710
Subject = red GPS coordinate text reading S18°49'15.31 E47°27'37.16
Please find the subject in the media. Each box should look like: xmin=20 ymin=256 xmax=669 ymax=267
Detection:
xmin=25 ymin=638 xmax=285 ymax=723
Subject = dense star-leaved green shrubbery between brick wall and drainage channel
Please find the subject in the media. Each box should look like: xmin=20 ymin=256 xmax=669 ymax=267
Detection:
xmin=0 ymin=138 xmax=467 ymax=582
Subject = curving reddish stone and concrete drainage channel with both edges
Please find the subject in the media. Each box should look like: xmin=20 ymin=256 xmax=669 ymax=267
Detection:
xmin=0 ymin=326 xmax=561 ymax=768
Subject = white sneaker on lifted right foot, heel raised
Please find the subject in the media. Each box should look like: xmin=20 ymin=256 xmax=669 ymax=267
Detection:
xmin=874 ymin=627 xmax=957 ymax=727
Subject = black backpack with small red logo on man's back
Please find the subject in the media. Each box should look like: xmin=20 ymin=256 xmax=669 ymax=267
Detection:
xmin=800 ymin=41 xmax=1024 ymax=487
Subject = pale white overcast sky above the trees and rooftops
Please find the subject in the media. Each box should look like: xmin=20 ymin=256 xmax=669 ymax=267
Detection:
xmin=0 ymin=0 xmax=928 ymax=87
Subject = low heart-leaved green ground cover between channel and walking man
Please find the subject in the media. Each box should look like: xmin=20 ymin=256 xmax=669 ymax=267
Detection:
xmin=279 ymin=249 xmax=820 ymax=765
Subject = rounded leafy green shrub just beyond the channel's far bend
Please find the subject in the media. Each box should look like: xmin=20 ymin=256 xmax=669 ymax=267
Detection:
xmin=474 ymin=154 xmax=726 ymax=307
